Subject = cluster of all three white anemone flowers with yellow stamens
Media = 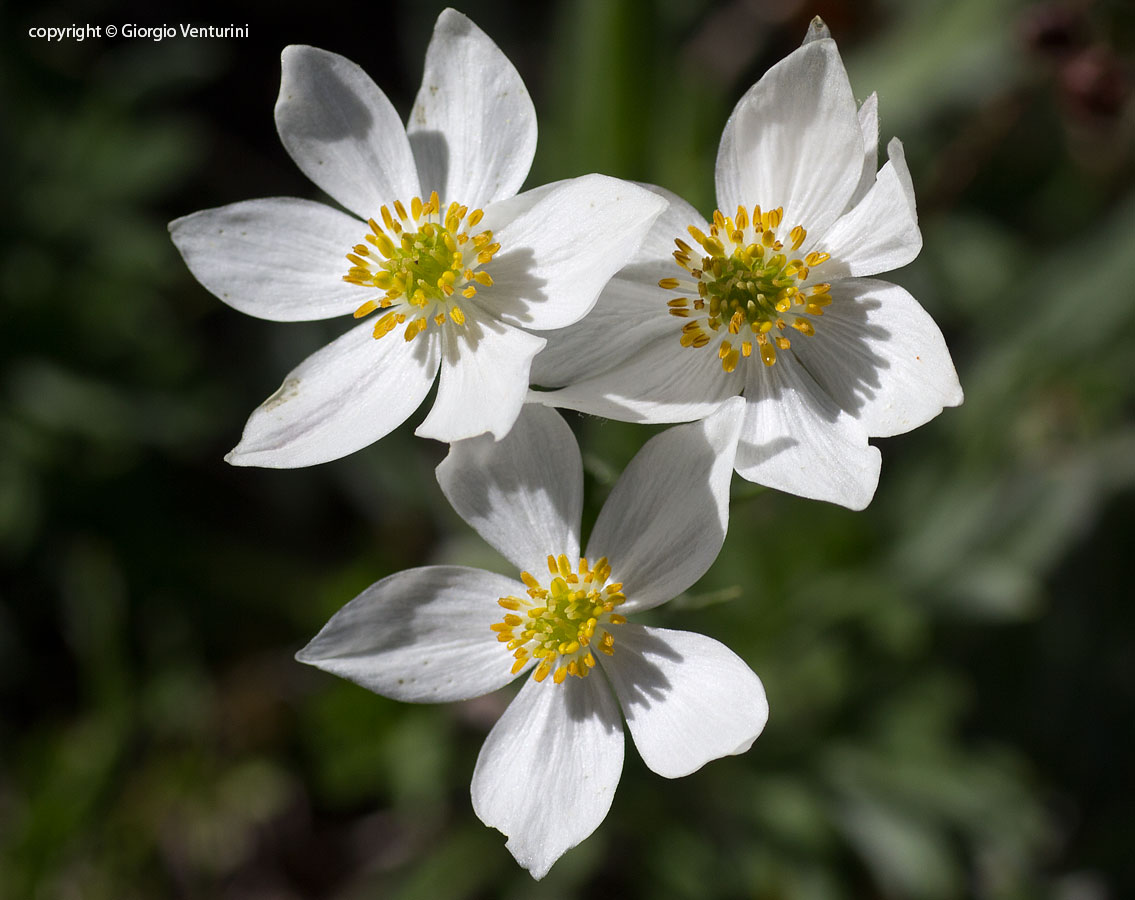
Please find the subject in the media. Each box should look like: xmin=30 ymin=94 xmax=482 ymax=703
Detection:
xmin=170 ymin=9 xmax=961 ymax=878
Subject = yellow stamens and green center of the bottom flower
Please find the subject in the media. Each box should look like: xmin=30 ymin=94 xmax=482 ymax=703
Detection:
xmin=491 ymin=554 xmax=627 ymax=684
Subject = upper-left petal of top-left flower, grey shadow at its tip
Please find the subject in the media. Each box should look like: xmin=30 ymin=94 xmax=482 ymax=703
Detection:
xmin=276 ymin=44 xmax=420 ymax=219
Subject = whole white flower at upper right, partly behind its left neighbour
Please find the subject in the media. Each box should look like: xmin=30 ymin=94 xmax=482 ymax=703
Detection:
xmin=530 ymin=19 xmax=962 ymax=510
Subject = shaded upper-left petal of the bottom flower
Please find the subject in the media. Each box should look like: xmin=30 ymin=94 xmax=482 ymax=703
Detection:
xmin=437 ymin=405 xmax=583 ymax=573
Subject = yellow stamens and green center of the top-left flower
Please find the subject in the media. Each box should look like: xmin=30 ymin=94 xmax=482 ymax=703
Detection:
xmin=343 ymin=191 xmax=501 ymax=340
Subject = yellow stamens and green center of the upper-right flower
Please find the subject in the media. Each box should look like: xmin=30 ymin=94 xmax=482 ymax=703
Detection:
xmin=658 ymin=207 xmax=832 ymax=372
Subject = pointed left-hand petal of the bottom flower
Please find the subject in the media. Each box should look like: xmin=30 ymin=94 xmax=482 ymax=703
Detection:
xmin=295 ymin=565 xmax=526 ymax=703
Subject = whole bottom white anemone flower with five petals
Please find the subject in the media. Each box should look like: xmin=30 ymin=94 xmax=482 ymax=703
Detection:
xmin=296 ymin=401 xmax=768 ymax=878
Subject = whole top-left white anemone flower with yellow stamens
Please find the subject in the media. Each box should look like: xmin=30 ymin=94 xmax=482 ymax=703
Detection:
xmin=170 ymin=9 xmax=665 ymax=468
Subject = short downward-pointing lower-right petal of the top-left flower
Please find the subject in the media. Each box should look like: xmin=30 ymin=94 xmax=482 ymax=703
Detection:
xmin=414 ymin=306 xmax=545 ymax=441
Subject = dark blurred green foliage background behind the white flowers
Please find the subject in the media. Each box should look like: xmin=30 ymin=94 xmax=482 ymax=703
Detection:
xmin=0 ymin=0 xmax=1135 ymax=900
